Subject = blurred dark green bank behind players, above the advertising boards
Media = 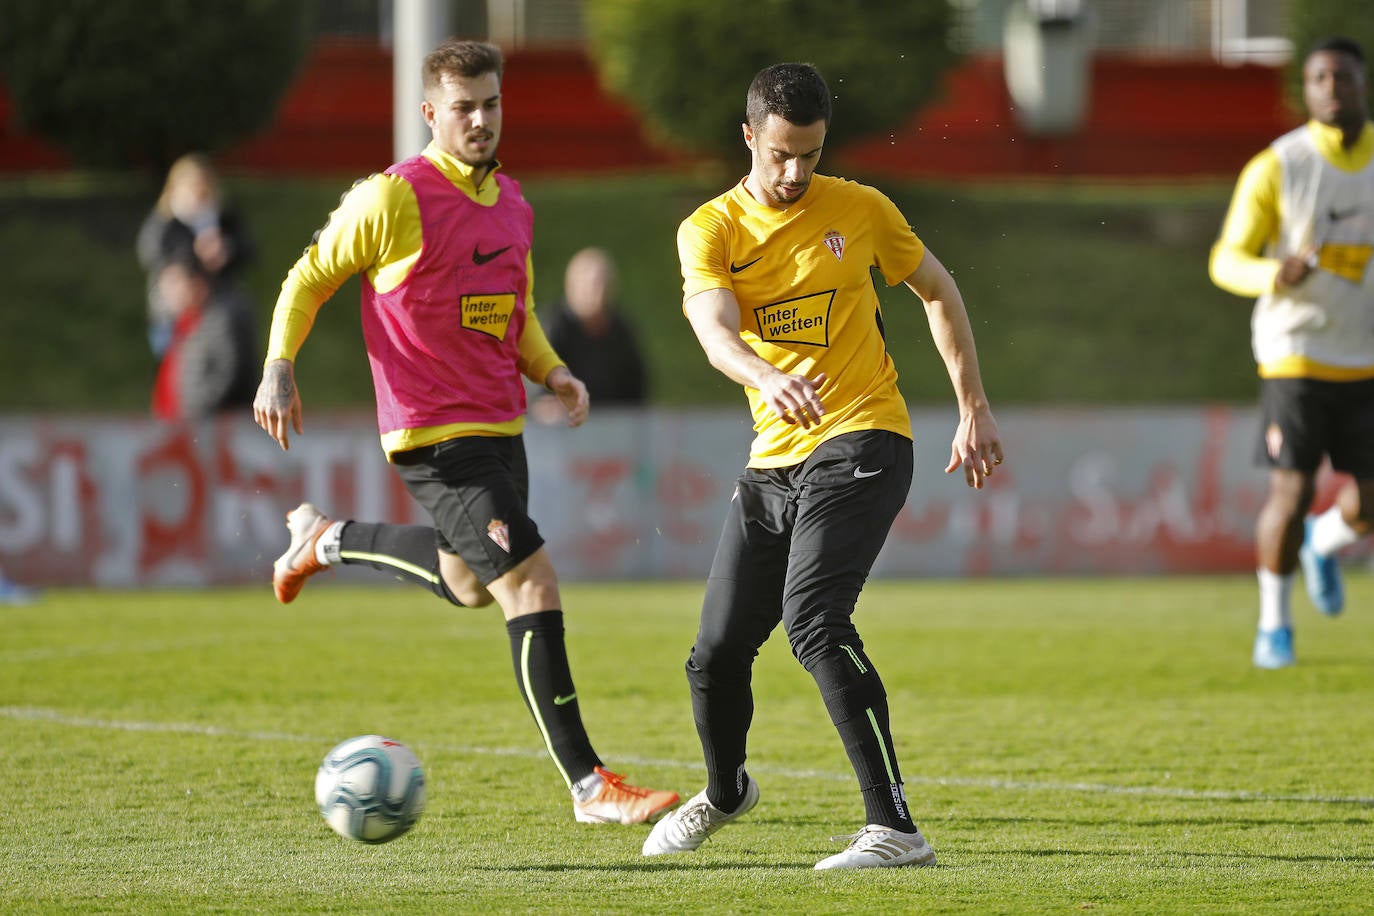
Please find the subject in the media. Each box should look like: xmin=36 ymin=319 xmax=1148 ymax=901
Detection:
xmin=0 ymin=173 xmax=1256 ymax=411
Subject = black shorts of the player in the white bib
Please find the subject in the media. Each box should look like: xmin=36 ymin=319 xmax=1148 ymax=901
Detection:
xmin=1256 ymin=379 xmax=1374 ymax=479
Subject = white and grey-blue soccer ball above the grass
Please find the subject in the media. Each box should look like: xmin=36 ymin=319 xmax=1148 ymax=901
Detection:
xmin=315 ymin=735 xmax=425 ymax=843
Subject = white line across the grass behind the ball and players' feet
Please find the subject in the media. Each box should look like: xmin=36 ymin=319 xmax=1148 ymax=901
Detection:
xmin=8 ymin=706 xmax=1374 ymax=806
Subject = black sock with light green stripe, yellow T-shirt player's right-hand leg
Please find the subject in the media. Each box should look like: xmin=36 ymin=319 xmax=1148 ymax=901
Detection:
xmin=811 ymin=644 xmax=916 ymax=834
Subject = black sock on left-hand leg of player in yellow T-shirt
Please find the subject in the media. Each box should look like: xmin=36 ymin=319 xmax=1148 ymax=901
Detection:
xmin=687 ymin=650 xmax=754 ymax=812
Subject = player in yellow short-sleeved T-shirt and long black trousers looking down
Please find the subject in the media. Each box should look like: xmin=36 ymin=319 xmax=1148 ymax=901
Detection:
xmin=643 ymin=63 xmax=1002 ymax=869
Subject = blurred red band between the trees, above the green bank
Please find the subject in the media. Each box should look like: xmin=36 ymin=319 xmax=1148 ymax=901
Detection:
xmin=0 ymin=40 xmax=1298 ymax=179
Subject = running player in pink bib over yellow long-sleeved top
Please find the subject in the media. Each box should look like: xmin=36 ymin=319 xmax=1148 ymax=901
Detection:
xmin=253 ymin=41 xmax=677 ymax=824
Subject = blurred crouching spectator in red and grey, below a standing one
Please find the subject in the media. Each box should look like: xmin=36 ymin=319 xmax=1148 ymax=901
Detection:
xmin=153 ymin=260 xmax=260 ymax=420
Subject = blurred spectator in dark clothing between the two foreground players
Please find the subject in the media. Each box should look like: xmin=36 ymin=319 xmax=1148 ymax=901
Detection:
xmin=533 ymin=249 xmax=647 ymax=422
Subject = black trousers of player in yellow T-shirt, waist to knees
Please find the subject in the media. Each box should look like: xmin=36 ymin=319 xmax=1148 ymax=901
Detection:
xmin=697 ymin=430 xmax=914 ymax=663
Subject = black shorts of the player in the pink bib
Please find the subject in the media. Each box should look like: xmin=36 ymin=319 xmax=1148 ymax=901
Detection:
xmin=392 ymin=435 xmax=544 ymax=585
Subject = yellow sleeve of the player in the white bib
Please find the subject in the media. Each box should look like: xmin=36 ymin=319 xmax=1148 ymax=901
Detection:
xmin=1208 ymin=147 xmax=1283 ymax=297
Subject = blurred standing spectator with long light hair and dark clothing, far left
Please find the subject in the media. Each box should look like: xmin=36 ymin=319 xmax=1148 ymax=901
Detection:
xmin=137 ymin=152 xmax=253 ymax=357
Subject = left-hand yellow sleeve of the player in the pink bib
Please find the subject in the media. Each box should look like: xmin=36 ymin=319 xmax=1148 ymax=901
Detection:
xmin=267 ymin=174 xmax=420 ymax=360
